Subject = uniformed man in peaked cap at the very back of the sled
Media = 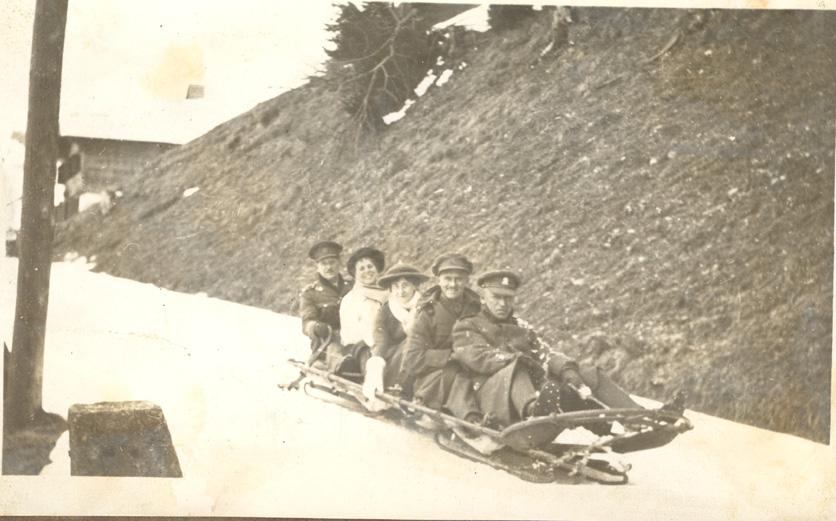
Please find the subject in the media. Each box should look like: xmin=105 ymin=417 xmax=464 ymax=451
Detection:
xmin=299 ymin=241 xmax=353 ymax=360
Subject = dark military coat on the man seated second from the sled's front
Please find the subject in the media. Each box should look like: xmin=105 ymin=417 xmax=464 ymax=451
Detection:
xmin=402 ymin=286 xmax=481 ymax=378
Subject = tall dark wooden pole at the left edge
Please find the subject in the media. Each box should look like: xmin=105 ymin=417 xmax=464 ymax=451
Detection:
xmin=4 ymin=0 xmax=68 ymax=432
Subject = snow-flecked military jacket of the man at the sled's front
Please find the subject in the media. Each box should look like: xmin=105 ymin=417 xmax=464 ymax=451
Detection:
xmin=453 ymin=308 xmax=577 ymax=381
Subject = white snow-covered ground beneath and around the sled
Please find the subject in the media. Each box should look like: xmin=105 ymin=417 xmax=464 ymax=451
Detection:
xmin=0 ymin=259 xmax=836 ymax=520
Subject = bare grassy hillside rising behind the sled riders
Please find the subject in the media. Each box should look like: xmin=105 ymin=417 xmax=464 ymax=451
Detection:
xmin=58 ymin=8 xmax=836 ymax=442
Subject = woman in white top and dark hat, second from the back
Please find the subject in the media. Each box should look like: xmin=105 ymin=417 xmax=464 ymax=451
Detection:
xmin=337 ymin=246 xmax=389 ymax=373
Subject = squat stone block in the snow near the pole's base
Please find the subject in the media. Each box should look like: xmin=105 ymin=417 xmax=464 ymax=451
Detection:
xmin=68 ymin=401 xmax=183 ymax=478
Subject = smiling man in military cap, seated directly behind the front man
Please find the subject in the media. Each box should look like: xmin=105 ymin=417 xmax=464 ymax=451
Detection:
xmin=400 ymin=253 xmax=480 ymax=418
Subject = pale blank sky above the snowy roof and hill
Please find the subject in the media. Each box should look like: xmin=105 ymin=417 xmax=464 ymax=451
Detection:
xmin=0 ymin=0 xmax=335 ymax=138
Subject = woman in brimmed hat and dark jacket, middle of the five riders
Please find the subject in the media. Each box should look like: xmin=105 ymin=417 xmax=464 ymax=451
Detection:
xmin=363 ymin=263 xmax=429 ymax=408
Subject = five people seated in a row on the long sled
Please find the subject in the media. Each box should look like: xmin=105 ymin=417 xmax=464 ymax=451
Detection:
xmin=299 ymin=241 xmax=640 ymax=452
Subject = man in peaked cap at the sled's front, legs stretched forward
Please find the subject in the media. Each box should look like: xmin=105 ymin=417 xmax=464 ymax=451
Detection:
xmin=453 ymin=270 xmax=639 ymax=426
